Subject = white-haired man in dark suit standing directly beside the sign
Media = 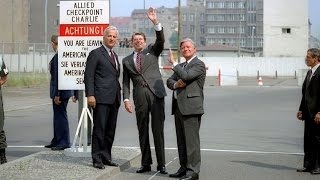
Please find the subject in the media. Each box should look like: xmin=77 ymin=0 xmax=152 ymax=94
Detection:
xmin=84 ymin=26 xmax=121 ymax=169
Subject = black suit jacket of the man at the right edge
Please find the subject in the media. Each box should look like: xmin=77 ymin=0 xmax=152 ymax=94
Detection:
xmin=299 ymin=67 xmax=320 ymax=119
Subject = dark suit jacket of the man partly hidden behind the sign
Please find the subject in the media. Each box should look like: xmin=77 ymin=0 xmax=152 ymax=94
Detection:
xmin=50 ymin=53 xmax=73 ymax=99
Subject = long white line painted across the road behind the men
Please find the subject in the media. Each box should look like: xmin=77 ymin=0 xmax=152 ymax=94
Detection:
xmin=8 ymin=145 xmax=304 ymax=155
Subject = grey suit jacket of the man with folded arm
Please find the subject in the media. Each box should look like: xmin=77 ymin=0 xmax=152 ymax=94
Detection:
xmin=167 ymin=57 xmax=206 ymax=115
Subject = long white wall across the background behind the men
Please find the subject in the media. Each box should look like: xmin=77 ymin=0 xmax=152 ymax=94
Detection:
xmin=3 ymin=52 xmax=308 ymax=77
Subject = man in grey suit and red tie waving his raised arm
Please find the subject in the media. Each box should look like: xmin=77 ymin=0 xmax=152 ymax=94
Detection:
xmin=122 ymin=8 xmax=167 ymax=174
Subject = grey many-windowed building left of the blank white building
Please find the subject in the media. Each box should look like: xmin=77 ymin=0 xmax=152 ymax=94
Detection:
xmin=182 ymin=0 xmax=263 ymax=52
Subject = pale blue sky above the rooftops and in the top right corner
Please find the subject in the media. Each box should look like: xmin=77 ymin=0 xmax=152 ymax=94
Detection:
xmin=110 ymin=0 xmax=320 ymax=39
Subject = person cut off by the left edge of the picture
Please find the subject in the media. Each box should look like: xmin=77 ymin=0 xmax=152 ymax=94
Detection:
xmin=0 ymin=58 xmax=9 ymax=164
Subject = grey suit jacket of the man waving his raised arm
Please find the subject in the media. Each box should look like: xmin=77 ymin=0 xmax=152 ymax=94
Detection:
xmin=122 ymin=30 xmax=167 ymax=100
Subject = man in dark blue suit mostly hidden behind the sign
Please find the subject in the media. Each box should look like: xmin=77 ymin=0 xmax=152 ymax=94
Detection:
xmin=45 ymin=35 xmax=77 ymax=150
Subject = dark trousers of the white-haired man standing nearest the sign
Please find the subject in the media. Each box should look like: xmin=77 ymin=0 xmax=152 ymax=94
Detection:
xmin=91 ymin=103 xmax=119 ymax=163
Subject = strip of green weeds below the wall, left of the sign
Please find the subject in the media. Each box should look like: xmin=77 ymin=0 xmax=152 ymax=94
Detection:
xmin=6 ymin=72 xmax=49 ymax=87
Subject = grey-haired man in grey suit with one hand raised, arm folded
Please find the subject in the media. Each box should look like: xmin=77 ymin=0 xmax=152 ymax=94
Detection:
xmin=167 ymin=39 xmax=206 ymax=179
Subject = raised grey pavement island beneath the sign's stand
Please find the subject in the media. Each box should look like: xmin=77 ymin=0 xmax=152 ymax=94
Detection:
xmin=0 ymin=147 xmax=141 ymax=180
